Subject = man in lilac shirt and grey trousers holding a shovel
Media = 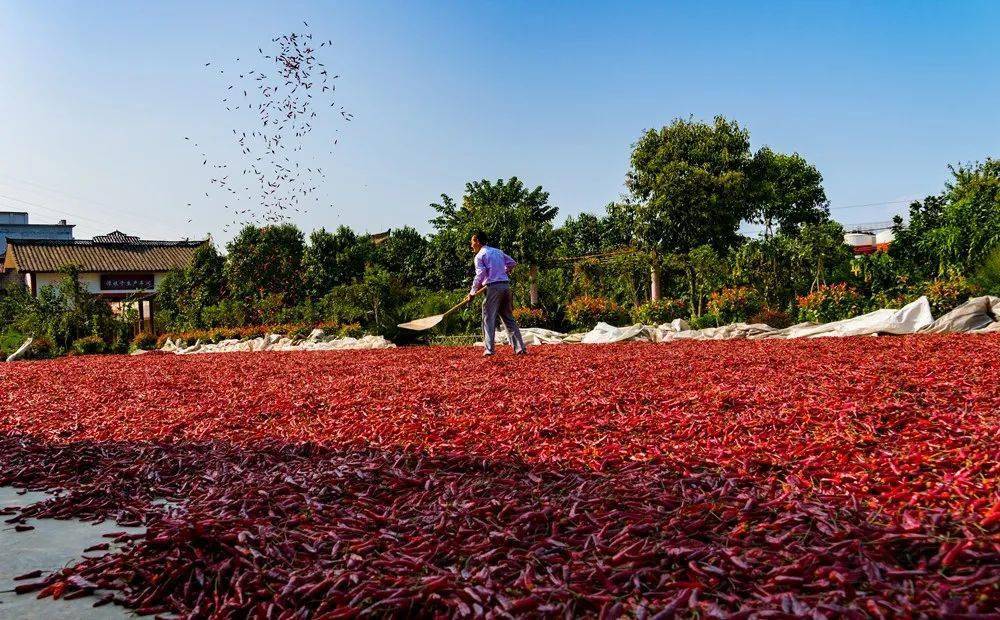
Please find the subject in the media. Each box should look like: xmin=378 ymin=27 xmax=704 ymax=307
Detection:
xmin=469 ymin=232 xmax=528 ymax=357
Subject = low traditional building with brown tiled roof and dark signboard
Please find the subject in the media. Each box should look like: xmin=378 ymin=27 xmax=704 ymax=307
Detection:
xmin=3 ymin=230 xmax=207 ymax=331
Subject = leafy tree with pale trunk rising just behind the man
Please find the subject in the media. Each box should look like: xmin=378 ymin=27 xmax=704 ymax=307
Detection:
xmin=431 ymin=177 xmax=558 ymax=305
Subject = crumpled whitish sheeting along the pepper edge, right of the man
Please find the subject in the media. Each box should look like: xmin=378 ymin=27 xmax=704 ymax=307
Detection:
xmin=488 ymin=297 xmax=1000 ymax=345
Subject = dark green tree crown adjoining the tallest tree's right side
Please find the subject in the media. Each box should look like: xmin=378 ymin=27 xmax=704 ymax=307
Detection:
xmin=749 ymin=146 xmax=830 ymax=237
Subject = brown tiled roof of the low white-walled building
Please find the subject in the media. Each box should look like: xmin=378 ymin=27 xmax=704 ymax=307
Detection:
xmin=4 ymin=231 xmax=205 ymax=273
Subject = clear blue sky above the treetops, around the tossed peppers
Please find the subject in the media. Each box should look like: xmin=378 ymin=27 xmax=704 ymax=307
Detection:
xmin=0 ymin=0 xmax=1000 ymax=242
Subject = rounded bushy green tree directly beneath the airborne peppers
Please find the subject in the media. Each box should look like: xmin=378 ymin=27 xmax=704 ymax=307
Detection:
xmin=225 ymin=224 xmax=305 ymax=304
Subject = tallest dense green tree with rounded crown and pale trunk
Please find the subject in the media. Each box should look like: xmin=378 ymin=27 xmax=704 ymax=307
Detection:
xmin=626 ymin=116 xmax=752 ymax=300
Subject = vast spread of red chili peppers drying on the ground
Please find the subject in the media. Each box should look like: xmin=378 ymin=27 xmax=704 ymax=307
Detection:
xmin=0 ymin=335 xmax=1000 ymax=618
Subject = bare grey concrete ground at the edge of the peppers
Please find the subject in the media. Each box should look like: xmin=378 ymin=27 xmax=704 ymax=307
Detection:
xmin=0 ymin=487 xmax=142 ymax=620
